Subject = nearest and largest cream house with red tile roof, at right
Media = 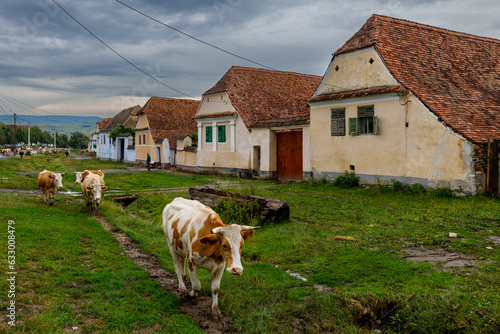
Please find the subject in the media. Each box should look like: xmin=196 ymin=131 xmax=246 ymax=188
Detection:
xmin=309 ymin=15 xmax=500 ymax=194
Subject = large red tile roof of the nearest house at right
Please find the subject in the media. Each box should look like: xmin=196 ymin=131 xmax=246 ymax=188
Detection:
xmin=326 ymin=15 xmax=500 ymax=143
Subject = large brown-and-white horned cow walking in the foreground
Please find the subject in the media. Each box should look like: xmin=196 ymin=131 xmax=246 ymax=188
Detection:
xmin=162 ymin=197 xmax=260 ymax=316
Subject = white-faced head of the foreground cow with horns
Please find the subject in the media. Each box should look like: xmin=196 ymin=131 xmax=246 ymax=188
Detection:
xmin=200 ymin=224 xmax=260 ymax=275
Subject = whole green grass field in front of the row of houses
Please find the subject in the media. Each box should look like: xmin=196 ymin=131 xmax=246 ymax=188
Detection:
xmin=0 ymin=155 xmax=500 ymax=333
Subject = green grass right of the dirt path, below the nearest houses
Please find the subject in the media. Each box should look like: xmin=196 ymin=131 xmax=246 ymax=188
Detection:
xmin=99 ymin=182 xmax=500 ymax=333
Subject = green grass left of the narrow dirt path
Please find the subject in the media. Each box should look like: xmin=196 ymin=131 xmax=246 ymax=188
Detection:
xmin=0 ymin=195 xmax=202 ymax=333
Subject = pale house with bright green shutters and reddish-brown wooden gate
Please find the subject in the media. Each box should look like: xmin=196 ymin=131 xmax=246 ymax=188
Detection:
xmin=191 ymin=66 xmax=321 ymax=179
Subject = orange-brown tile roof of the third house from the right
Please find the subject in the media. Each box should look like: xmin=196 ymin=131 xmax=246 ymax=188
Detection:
xmin=140 ymin=96 xmax=200 ymax=145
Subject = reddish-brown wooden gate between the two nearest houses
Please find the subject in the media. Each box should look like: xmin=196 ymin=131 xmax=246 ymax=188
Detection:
xmin=276 ymin=130 xmax=303 ymax=180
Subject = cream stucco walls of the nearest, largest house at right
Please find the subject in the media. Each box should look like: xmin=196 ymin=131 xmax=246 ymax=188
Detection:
xmin=304 ymin=50 xmax=476 ymax=193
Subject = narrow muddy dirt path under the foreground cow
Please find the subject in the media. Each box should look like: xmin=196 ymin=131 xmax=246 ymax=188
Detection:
xmin=93 ymin=216 xmax=236 ymax=334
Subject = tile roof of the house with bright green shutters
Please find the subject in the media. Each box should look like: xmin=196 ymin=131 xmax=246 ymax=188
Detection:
xmin=202 ymin=66 xmax=321 ymax=129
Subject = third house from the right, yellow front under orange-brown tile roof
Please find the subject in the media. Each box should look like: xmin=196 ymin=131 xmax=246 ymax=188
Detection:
xmin=135 ymin=96 xmax=200 ymax=167
